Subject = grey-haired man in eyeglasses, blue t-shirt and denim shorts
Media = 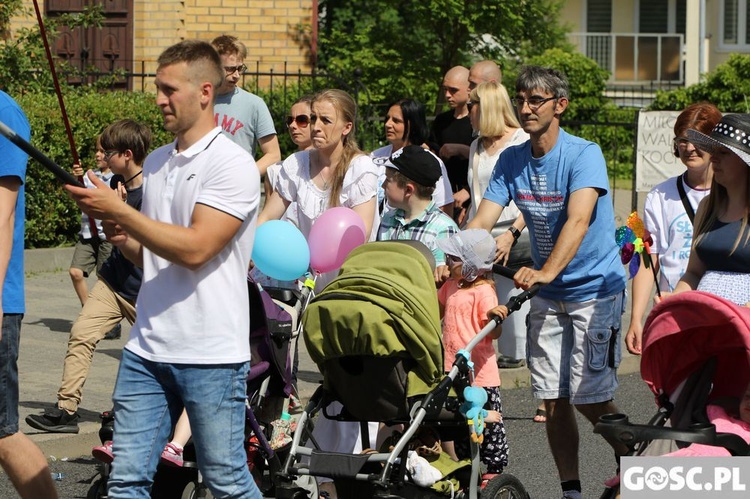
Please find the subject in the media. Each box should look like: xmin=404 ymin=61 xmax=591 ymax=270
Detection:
xmin=469 ymin=66 xmax=626 ymax=499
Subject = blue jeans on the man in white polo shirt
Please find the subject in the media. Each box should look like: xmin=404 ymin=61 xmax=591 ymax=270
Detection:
xmin=109 ymin=350 xmax=262 ymax=499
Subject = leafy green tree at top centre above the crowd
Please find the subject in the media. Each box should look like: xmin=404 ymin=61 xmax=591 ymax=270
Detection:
xmin=319 ymin=0 xmax=565 ymax=109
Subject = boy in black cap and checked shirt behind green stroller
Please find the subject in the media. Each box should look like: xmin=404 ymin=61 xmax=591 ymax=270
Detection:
xmin=378 ymin=145 xmax=458 ymax=278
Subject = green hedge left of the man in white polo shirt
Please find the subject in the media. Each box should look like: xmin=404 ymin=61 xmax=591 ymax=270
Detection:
xmin=14 ymin=91 xmax=173 ymax=248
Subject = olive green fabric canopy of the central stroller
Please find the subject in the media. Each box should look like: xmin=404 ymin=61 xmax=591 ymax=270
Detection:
xmin=302 ymin=241 xmax=443 ymax=396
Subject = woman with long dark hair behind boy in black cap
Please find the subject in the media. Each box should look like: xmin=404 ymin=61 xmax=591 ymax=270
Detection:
xmin=370 ymin=99 xmax=453 ymax=216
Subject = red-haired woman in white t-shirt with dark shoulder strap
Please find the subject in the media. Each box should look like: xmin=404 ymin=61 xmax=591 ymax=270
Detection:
xmin=625 ymin=102 xmax=721 ymax=355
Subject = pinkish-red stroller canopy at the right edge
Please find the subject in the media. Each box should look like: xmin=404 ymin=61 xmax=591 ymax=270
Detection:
xmin=641 ymin=291 xmax=750 ymax=399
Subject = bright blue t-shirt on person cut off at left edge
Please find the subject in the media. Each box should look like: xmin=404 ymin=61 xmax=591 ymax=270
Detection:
xmin=0 ymin=90 xmax=31 ymax=314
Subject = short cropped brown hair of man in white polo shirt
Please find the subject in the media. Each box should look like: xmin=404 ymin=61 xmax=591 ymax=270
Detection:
xmin=156 ymin=40 xmax=224 ymax=89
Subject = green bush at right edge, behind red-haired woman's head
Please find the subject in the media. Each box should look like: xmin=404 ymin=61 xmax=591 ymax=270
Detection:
xmin=649 ymin=54 xmax=750 ymax=113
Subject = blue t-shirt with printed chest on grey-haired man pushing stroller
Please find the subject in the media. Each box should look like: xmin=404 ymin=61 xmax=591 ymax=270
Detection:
xmin=484 ymin=129 xmax=626 ymax=302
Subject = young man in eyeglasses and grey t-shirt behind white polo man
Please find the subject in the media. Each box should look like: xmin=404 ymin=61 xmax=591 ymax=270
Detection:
xmin=211 ymin=35 xmax=281 ymax=175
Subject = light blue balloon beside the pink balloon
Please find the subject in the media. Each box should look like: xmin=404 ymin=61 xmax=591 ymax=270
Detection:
xmin=252 ymin=220 xmax=310 ymax=281
